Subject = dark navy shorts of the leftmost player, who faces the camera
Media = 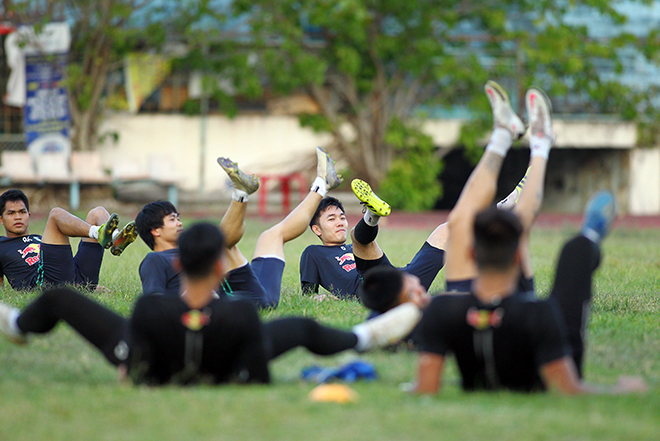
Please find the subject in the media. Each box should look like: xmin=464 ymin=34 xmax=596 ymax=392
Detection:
xmin=37 ymin=240 xmax=104 ymax=287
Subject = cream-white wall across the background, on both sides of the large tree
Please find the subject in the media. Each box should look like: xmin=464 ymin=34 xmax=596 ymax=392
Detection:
xmin=99 ymin=114 xmax=660 ymax=214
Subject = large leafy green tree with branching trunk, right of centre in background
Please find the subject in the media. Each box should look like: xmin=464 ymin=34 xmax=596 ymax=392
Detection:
xmin=233 ymin=0 xmax=659 ymax=203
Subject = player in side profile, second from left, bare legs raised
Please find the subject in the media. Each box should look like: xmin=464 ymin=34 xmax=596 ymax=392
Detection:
xmin=136 ymin=148 xmax=341 ymax=308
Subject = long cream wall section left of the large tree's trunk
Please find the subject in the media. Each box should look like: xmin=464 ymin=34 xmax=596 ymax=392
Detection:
xmin=100 ymin=114 xmax=330 ymax=191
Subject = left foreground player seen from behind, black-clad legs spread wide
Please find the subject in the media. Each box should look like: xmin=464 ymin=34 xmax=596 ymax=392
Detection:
xmin=0 ymin=223 xmax=421 ymax=385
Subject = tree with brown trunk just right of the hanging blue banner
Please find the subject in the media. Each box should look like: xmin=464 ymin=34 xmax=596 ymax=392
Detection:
xmin=4 ymin=0 xmax=165 ymax=150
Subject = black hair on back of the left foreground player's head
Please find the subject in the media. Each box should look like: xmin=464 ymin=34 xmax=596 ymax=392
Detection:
xmin=179 ymin=222 xmax=225 ymax=279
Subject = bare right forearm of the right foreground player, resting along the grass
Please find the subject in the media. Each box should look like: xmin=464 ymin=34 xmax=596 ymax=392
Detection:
xmin=541 ymin=356 xmax=647 ymax=395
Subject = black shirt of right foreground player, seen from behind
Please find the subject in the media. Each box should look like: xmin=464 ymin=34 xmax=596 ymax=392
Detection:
xmin=421 ymin=293 xmax=570 ymax=391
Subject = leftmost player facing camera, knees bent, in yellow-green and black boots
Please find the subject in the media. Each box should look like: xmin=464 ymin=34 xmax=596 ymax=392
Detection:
xmin=0 ymin=189 xmax=137 ymax=290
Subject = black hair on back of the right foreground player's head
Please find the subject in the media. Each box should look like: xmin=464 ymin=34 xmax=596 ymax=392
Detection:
xmin=474 ymin=206 xmax=523 ymax=270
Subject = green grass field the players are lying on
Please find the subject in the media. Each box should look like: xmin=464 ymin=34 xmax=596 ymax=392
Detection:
xmin=0 ymin=215 xmax=660 ymax=441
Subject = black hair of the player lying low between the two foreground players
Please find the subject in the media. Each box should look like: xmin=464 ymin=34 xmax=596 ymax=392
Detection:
xmin=358 ymin=265 xmax=404 ymax=313
